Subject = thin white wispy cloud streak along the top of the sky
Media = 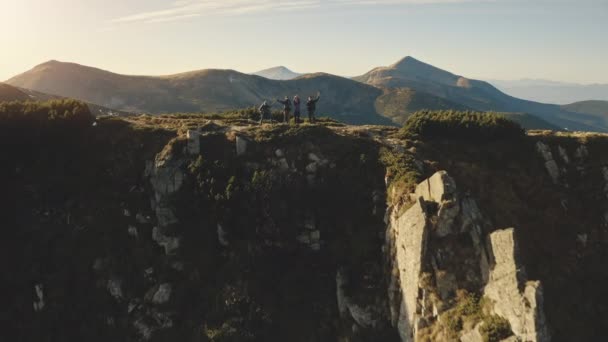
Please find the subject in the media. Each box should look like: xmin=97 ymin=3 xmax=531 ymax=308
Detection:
xmin=112 ymin=0 xmax=492 ymax=24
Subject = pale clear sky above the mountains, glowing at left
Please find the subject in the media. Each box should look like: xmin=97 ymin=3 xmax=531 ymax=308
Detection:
xmin=0 ymin=0 xmax=608 ymax=83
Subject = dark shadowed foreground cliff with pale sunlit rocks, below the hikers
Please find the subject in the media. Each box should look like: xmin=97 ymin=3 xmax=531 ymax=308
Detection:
xmin=0 ymin=113 xmax=608 ymax=341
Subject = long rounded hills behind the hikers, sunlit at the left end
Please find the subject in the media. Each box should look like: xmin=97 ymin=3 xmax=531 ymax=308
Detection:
xmin=7 ymin=61 xmax=391 ymax=124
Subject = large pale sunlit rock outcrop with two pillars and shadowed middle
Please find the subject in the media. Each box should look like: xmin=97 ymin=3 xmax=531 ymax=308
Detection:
xmin=387 ymin=171 xmax=549 ymax=342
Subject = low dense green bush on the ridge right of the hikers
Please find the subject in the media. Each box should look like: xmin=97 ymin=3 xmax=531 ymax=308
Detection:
xmin=400 ymin=110 xmax=524 ymax=142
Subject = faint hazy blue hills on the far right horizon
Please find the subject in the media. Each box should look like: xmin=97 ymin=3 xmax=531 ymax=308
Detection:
xmin=489 ymin=79 xmax=608 ymax=104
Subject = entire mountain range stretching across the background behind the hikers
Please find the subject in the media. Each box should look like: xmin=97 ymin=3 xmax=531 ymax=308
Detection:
xmin=6 ymin=57 xmax=608 ymax=132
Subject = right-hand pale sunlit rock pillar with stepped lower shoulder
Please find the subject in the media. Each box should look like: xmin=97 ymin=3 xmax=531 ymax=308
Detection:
xmin=484 ymin=228 xmax=549 ymax=342
